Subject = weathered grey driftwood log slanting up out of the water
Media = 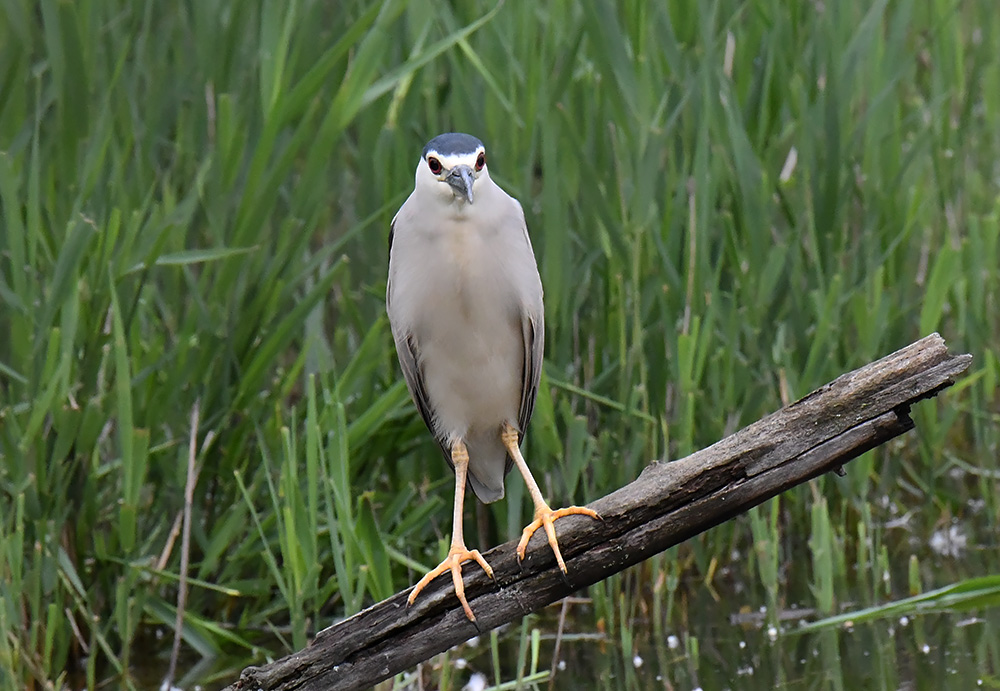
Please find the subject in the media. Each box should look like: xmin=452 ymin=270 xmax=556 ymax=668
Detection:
xmin=230 ymin=334 xmax=972 ymax=691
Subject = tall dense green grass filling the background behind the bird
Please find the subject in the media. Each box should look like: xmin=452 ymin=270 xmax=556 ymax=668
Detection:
xmin=0 ymin=0 xmax=1000 ymax=688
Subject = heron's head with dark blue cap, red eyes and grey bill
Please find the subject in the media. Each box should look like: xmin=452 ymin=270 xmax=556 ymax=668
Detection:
xmin=417 ymin=132 xmax=489 ymax=204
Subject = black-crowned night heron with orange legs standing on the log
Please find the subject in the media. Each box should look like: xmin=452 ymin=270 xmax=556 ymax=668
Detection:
xmin=386 ymin=132 xmax=600 ymax=622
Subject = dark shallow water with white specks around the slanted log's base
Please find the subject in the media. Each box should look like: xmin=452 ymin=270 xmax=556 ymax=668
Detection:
xmin=103 ymin=500 xmax=1000 ymax=691
